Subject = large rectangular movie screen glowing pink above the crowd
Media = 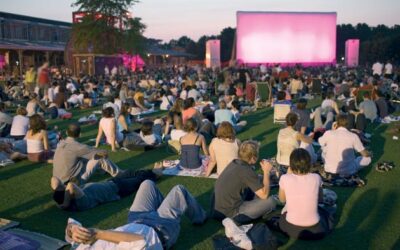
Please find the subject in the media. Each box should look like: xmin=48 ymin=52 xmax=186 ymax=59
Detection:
xmin=236 ymin=11 xmax=336 ymax=64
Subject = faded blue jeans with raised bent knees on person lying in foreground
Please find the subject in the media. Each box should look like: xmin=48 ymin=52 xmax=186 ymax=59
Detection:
xmin=128 ymin=180 xmax=206 ymax=249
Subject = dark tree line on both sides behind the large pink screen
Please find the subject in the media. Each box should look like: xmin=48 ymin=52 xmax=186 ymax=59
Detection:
xmin=162 ymin=23 xmax=400 ymax=64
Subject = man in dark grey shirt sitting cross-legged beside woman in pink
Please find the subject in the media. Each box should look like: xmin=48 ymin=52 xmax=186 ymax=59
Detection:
xmin=214 ymin=141 xmax=276 ymax=223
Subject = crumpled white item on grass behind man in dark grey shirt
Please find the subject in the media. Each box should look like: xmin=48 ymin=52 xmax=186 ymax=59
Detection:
xmin=222 ymin=218 xmax=253 ymax=250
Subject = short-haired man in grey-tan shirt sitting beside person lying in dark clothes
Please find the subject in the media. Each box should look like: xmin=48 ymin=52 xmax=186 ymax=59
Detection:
xmin=53 ymin=123 xmax=122 ymax=183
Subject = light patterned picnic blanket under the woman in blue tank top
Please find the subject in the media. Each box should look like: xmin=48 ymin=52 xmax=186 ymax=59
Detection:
xmin=163 ymin=157 xmax=218 ymax=179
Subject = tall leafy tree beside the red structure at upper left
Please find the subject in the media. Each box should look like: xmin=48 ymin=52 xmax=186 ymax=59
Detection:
xmin=72 ymin=0 xmax=145 ymax=54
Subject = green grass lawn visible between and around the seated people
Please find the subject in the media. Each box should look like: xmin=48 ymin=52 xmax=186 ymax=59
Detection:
xmin=0 ymin=100 xmax=400 ymax=249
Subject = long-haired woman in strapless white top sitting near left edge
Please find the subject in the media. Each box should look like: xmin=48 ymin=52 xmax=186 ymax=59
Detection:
xmin=25 ymin=114 xmax=54 ymax=163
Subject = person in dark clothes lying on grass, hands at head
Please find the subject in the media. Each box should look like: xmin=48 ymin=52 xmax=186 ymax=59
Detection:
xmin=51 ymin=164 xmax=162 ymax=211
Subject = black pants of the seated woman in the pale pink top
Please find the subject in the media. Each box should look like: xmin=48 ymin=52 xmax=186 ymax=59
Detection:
xmin=279 ymin=207 xmax=334 ymax=240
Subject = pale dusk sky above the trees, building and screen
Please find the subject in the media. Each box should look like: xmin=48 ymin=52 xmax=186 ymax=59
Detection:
xmin=0 ymin=0 xmax=400 ymax=41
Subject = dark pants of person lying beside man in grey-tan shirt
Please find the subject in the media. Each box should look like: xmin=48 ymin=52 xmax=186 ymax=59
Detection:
xmin=110 ymin=169 xmax=156 ymax=197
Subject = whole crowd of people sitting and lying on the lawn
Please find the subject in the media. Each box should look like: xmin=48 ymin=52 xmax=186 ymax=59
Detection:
xmin=0 ymin=62 xmax=400 ymax=249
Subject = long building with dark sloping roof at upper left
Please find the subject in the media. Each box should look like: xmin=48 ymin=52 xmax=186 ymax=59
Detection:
xmin=0 ymin=12 xmax=72 ymax=74
